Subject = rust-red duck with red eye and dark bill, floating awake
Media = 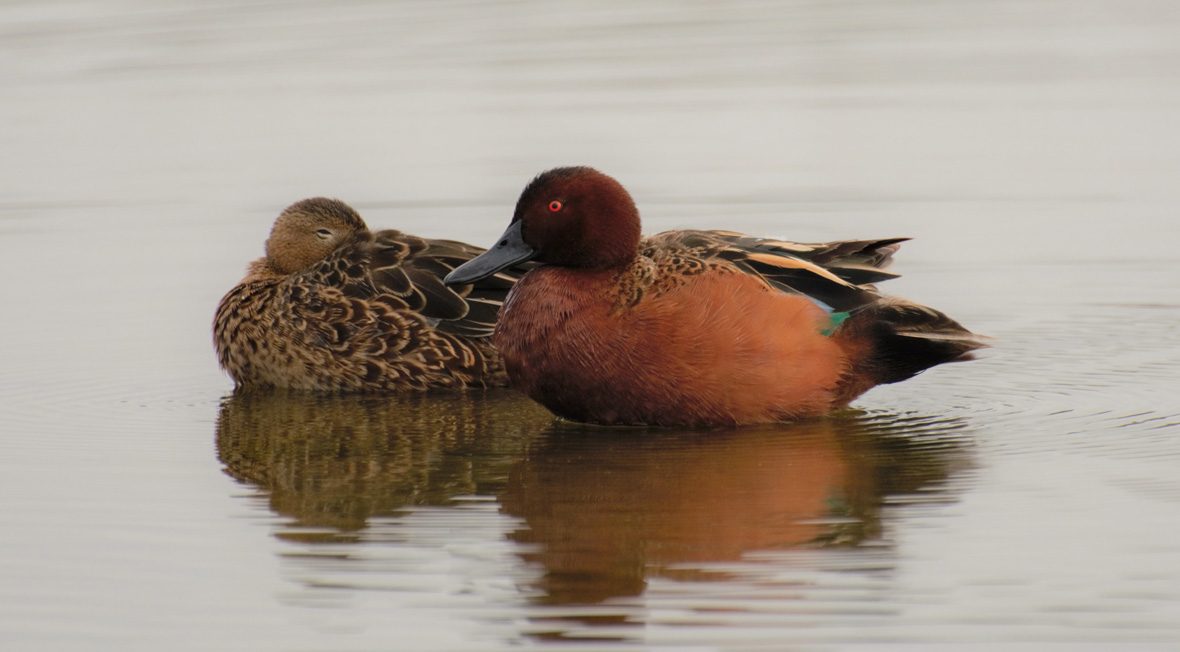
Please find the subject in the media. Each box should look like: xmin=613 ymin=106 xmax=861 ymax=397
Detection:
xmin=447 ymin=167 xmax=983 ymax=426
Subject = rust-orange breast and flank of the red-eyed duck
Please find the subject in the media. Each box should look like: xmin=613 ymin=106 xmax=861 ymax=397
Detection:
xmin=494 ymin=257 xmax=847 ymax=426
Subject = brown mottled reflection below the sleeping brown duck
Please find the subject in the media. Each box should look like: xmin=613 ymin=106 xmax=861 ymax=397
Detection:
xmin=217 ymin=390 xmax=552 ymax=538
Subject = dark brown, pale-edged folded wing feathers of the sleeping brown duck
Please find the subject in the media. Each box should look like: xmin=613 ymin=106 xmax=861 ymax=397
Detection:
xmin=296 ymin=230 xmax=524 ymax=337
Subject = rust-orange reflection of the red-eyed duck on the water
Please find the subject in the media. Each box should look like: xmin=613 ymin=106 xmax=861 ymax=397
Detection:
xmin=502 ymin=419 xmax=957 ymax=604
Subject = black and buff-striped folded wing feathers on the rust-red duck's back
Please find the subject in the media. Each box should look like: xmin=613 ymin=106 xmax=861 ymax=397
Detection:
xmin=641 ymin=231 xmax=904 ymax=311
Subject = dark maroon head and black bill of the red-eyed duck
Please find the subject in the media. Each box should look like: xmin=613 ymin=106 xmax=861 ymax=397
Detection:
xmin=446 ymin=167 xmax=640 ymax=284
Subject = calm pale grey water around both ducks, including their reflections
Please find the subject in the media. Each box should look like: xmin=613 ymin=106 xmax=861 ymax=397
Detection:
xmin=0 ymin=0 xmax=1180 ymax=652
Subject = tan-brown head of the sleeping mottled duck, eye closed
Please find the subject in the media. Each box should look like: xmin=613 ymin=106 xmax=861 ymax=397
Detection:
xmin=267 ymin=197 xmax=368 ymax=274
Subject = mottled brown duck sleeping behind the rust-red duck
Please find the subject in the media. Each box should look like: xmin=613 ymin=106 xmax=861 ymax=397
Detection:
xmin=214 ymin=198 xmax=526 ymax=391
